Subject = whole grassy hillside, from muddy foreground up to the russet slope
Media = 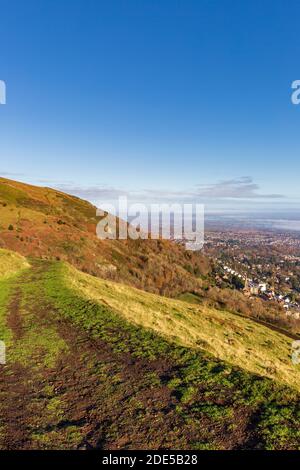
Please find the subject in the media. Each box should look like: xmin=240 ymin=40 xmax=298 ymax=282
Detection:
xmin=0 ymin=178 xmax=300 ymax=449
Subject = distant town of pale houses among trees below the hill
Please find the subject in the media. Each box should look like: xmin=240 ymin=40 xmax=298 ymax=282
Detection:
xmin=204 ymin=228 xmax=300 ymax=320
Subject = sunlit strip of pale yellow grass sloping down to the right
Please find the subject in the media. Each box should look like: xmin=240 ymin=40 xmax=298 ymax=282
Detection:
xmin=49 ymin=265 xmax=300 ymax=391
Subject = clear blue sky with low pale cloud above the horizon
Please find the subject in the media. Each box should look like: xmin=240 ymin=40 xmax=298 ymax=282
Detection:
xmin=0 ymin=0 xmax=300 ymax=209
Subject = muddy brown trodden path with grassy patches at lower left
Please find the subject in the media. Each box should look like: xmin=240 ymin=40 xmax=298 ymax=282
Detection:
xmin=0 ymin=265 xmax=195 ymax=449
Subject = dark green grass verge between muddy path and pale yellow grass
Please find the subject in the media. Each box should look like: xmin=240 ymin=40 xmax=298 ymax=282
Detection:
xmin=43 ymin=263 xmax=300 ymax=449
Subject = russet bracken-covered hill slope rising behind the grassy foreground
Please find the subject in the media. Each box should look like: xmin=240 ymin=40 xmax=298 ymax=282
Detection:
xmin=0 ymin=178 xmax=210 ymax=296
